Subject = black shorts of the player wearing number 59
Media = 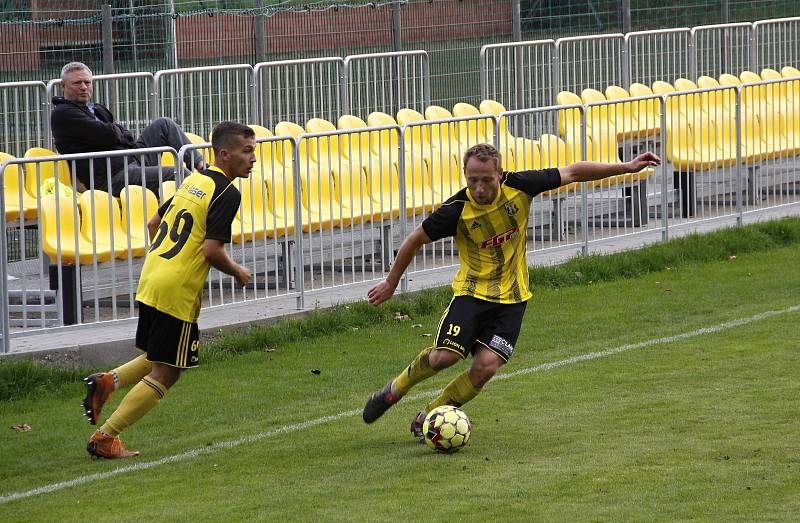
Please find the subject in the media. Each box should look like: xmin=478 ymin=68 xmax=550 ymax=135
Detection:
xmin=136 ymin=302 xmax=200 ymax=369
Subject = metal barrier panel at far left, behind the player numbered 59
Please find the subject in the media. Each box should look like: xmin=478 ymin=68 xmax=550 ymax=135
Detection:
xmin=0 ymin=147 xmax=176 ymax=351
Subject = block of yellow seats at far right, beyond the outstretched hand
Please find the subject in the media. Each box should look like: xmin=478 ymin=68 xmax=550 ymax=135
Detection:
xmin=557 ymin=67 xmax=800 ymax=171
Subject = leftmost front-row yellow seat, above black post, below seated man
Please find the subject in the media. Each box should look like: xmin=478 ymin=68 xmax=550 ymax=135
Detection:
xmin=41 ymin=196 xmax=111 ymax=265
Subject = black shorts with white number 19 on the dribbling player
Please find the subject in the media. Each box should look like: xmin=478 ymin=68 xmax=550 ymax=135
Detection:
xmin=434 ymin=296 xmax=527 ymax=362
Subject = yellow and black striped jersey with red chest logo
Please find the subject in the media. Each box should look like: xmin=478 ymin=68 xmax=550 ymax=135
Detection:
xmin=422 ymin=169 xmax=561 ymax=303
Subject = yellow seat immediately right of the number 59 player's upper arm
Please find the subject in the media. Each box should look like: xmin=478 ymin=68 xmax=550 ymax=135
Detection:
xmin=231 ymin=165 xmax=294 ymax=243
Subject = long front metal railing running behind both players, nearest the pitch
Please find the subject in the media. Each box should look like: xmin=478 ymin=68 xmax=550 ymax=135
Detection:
xmin=0 ymin=79 xmax=800 ymax=351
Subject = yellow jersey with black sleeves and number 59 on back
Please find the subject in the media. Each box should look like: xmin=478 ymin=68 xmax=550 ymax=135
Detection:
xmin=136 ymin=167 xmax=241 ymax=322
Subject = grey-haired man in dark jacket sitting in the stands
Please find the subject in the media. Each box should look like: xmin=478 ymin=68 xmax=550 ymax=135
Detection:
xmin=50 ymin=62 xmax=205 ymax=196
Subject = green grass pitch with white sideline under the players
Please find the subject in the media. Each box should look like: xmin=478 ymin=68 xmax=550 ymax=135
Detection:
xmin=0 ymin=232 xmax=800 ymax=521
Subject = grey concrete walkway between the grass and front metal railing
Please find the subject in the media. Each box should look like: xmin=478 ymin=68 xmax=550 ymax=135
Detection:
xmin=3 ymin=203 xmax=800 ymax=366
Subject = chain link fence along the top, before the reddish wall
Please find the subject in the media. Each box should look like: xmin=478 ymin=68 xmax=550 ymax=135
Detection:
xmin=0 ymin=0 xmax=797 ymax=107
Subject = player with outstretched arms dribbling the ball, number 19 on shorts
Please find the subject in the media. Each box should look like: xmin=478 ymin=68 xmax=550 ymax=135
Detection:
xmin=363 ymin=144 xmax=661 ymax=438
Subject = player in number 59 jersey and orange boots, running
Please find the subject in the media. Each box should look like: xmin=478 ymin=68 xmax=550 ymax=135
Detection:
xmin=83 ymin=122 xmax=256 ymax=459
